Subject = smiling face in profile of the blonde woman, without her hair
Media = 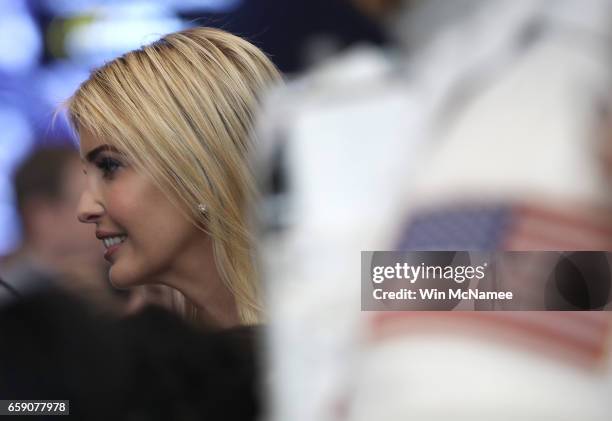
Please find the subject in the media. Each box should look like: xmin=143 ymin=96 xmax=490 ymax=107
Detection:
xmin=78 ymin=131 xmax=204 ymax=288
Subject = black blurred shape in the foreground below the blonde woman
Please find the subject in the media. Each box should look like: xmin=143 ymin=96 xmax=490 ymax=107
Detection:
xmin=0 ymin=290 xmax=260 ymax=421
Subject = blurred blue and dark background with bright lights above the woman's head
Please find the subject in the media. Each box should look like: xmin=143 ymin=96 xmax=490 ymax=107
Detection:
xmin=0 ymin=0 xmax=386 ymax=257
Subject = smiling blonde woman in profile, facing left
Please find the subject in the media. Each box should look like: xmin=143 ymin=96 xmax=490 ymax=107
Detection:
xmin=66 ymin=28 xmax=280 ymax=327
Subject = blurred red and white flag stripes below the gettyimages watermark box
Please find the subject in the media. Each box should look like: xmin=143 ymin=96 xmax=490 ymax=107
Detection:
xmin=368 ymin=311 xmax=612 ymax=367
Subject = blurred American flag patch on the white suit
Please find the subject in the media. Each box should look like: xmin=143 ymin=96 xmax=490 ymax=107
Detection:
xmin=390 ymin=203 xmax=612 ymax=365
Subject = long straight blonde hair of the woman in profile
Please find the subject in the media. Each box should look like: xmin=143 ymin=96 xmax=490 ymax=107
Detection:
xmin=66 ymin=28 xmax=280 ymax=324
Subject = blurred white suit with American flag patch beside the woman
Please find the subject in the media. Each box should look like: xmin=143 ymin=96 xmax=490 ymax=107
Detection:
xmin=257 ymin=0 xmax=612 ymax=421
